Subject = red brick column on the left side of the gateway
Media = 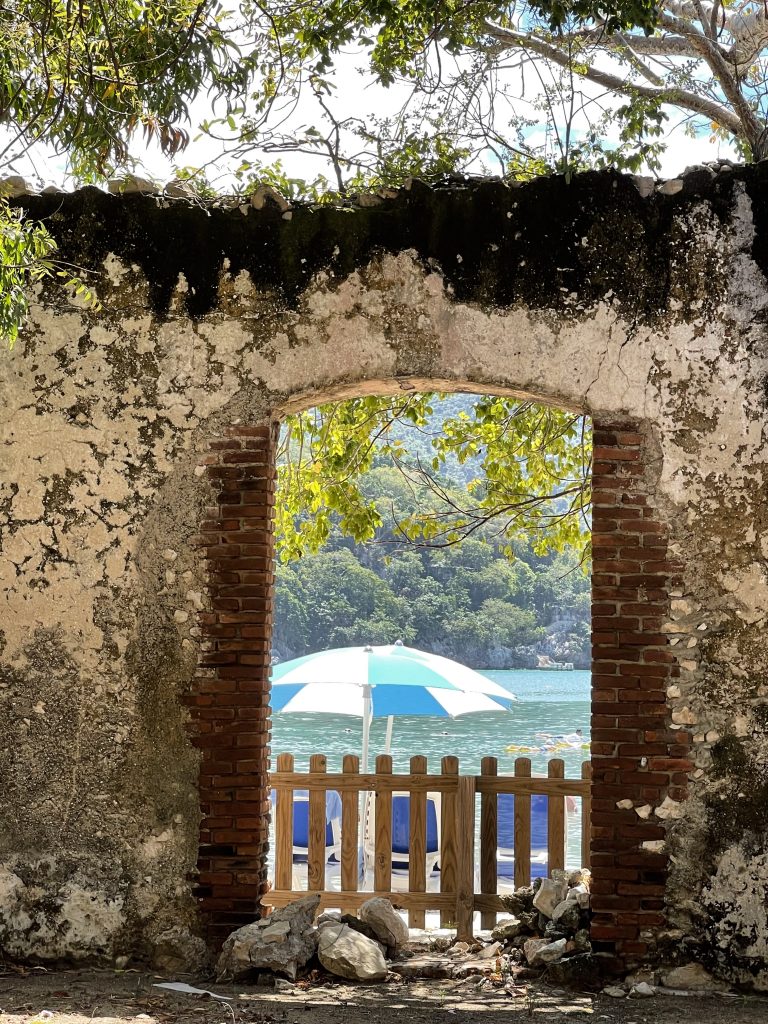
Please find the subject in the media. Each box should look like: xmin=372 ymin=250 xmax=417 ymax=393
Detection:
xmin=189 ymin=425 xmax=278 ymax=944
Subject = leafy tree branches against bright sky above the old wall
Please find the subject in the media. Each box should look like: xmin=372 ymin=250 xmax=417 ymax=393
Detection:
xmin=0 ymin=0 xmax=768 ymax=340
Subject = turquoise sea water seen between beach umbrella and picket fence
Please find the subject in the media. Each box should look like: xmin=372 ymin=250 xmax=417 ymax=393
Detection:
xmin=271 ymin=669 xmax=590 ymax=867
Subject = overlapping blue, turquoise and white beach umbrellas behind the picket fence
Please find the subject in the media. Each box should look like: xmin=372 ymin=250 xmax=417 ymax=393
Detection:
xmin=271 ymin=642 xmax=517 ymax=770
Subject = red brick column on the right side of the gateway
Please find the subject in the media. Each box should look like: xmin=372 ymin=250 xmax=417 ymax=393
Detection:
xmin=591 ymin=424 xmax=692 ymax=962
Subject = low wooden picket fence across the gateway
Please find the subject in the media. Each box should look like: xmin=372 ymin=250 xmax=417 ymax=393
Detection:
xmin=264 ymin=754 xmax=590 ymax=938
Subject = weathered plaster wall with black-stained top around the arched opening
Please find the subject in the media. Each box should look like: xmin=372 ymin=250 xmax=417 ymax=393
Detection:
xmin=0 ymin=166 xmax=768 ymax=988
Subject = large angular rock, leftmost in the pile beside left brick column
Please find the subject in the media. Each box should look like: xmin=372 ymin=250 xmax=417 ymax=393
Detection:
xmin=216 ymin=893 xmax=321 ymax=981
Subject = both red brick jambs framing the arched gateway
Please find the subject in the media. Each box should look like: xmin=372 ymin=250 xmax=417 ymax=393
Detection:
xmin=190 ymin=411 xmax=691 ymax=961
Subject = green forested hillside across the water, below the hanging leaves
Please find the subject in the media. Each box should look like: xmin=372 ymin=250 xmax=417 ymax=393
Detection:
xmin=273 ymin=466 xmax=590 ymax=669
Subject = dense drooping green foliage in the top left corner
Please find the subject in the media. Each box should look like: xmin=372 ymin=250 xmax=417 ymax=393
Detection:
xmin=0 ymin=0 xmax=240 ymax=180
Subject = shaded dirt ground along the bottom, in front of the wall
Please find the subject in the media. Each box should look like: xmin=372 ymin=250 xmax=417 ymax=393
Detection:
xmin=0 ymin=969 xmax=768 ymax=1024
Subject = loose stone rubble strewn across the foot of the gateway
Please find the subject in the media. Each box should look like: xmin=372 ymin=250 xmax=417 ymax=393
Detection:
xmin=217 ymin=868 xmax=725 ymax=999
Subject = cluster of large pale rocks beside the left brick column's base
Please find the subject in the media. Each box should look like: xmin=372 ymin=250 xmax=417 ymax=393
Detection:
xmin=216 ymin=894 xmax=409 ymax=981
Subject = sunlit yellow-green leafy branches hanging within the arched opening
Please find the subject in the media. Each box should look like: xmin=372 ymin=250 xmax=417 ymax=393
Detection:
xmin=276 ymin=394 xmax=591 ymax=561
